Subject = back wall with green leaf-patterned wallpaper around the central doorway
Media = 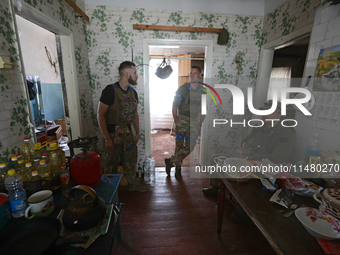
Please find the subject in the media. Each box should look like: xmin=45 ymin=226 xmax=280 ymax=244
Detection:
xmin=86 ymin=5 xmax=263 ymax=156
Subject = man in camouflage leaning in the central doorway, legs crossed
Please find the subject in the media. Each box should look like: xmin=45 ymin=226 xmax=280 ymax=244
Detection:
xmin=165 ymin=66 xmax=205 ymax=178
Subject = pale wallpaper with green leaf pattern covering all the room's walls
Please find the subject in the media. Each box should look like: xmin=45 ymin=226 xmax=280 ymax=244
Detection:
xmin=0 ymin=0 xmax=323 ymax=163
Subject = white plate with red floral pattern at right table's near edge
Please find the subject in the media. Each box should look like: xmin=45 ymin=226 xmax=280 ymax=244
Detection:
xmin=295 ymin=207 xmax=340 ymax=240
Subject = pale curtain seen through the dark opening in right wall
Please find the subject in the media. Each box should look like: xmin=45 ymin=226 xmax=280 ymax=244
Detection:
xmin=267 ymin=67 xmax=292 ymax=101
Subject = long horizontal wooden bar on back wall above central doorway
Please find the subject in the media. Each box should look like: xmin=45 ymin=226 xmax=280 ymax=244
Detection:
xmin=133 ymin=24 xmax=222 ymax=34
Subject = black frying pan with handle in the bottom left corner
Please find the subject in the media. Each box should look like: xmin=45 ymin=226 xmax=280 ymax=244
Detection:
xmin=0 ymin=217 xmax=89 ymax=255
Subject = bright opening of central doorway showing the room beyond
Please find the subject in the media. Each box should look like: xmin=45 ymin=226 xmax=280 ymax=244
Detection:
xmin=149 ymin=46 xmax=205 ymax=167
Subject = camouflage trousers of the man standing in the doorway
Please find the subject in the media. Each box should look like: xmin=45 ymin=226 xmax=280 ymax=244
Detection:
xmin=170 ymin=115 xmax=201 ymax=166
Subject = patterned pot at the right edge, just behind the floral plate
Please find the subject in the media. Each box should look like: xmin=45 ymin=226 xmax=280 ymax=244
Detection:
xmin=313 ymin=188 xmax=340 ymax=219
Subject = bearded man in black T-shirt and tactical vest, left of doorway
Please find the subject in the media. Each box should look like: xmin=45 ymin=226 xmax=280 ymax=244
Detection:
xmin=97 ymin=61 xmax=149 ymax=192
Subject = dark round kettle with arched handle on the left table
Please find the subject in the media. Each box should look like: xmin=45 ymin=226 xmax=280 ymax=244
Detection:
xmin=62 ymin=185 xmax=106 ymax=231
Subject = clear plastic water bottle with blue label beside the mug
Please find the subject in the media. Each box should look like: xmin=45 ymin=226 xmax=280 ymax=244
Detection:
xmin=5 ymin=169 xmax=27 ymax=218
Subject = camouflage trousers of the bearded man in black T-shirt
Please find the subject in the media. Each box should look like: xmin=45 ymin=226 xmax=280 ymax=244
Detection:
xmin=103 ymin=126 xmax=140 ymax=185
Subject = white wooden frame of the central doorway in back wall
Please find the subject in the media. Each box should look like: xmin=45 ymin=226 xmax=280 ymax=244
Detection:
xmin=143 ymin=39 xmax=213 ymax=164
